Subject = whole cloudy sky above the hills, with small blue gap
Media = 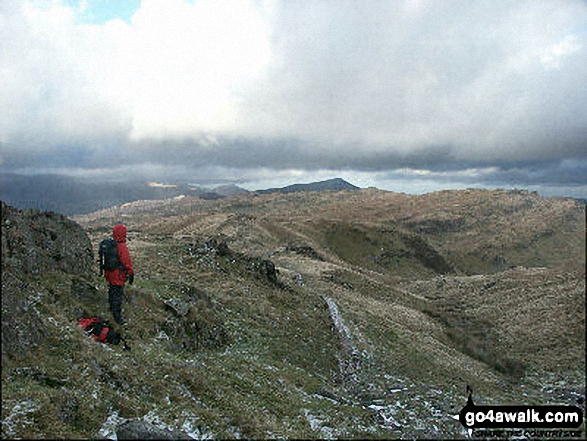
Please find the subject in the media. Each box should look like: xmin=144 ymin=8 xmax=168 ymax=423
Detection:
xmin=0 ymin=0 xmax=587 ymax=198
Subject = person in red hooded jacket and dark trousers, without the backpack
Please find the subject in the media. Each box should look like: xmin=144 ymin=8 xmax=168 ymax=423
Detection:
xmin=104 ymin=225 xmax=134 ymax=325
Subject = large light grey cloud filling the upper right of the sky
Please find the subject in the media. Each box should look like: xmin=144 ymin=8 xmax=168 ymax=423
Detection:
xmin=239 ymin=2 xmax=587 ymax=160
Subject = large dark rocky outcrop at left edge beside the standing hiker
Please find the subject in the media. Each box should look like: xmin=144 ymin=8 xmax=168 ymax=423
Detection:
xmin=2 ymin=203 xmax=93 ymax=360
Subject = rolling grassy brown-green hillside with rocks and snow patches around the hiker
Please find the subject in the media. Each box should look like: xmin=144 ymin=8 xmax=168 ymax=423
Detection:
xmin=2 ymin=189 xmax=585 ymax=438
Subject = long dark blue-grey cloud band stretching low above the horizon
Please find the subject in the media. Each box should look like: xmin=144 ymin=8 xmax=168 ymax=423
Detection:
xmin=0 ymin=138 xmax=587 ymax=190
